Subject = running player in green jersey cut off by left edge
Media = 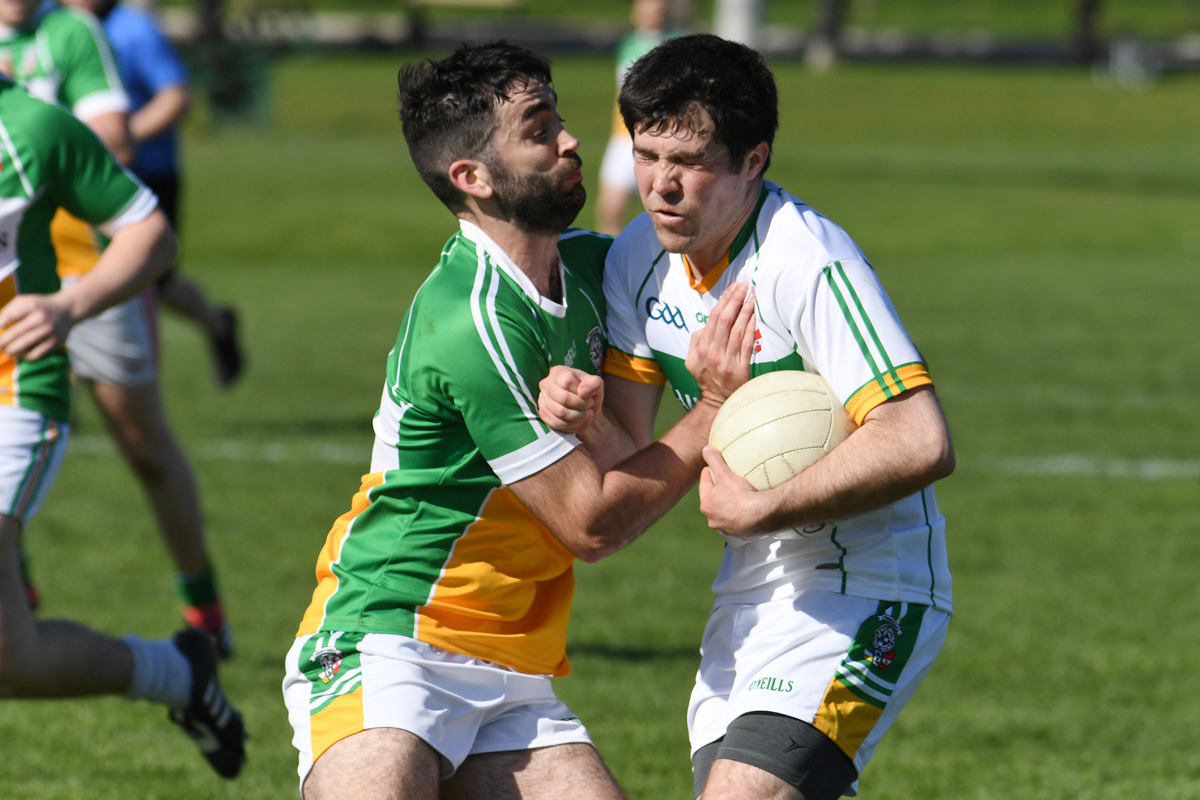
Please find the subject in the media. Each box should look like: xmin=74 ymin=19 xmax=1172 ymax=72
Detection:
xmin=0 ymin=78 xmax=245 ymax=777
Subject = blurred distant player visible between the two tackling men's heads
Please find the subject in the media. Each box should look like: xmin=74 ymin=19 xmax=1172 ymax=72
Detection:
xmin=596 ymin=0 xmax=668 ymax=236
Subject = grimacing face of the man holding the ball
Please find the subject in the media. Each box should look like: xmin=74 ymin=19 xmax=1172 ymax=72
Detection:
xmin=634 ymin=109 xmax=757 ymax=258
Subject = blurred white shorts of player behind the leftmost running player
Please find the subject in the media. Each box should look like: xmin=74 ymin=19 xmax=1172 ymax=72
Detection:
xmin=64 ymin=281 xmax=158 ymax=386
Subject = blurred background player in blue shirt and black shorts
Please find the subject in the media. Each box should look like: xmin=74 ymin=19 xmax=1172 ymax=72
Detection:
xmin=66 ymin=0 xmax=242 ymax=387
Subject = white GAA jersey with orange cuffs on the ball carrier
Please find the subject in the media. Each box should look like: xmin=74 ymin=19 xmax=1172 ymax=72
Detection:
xmin=604 ymin=181 xmax=952 ymax=610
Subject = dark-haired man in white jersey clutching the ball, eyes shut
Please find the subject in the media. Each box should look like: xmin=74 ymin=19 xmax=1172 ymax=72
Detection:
xmin=540 ymin=35 xmax=954 ymax=800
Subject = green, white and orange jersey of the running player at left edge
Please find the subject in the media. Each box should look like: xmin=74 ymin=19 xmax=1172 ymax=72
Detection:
xmin=0 ymin=78 xmax=158 ymax=421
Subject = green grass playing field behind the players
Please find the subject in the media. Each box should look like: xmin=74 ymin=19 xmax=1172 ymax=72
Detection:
xmin=0 ymin=58 xmax=1200 ymax=800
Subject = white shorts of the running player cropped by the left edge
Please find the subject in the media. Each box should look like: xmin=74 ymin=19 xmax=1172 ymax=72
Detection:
xmin=0 ymin=405 xmax=71 ymax=522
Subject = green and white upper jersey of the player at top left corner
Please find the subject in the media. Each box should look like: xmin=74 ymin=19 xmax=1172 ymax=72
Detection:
xmin=0 ymin=8 xmax=130 ymax=121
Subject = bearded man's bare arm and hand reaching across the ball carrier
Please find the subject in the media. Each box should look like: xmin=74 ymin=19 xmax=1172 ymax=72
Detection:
xmin=509 ymin=288 xmax=755 ymax=561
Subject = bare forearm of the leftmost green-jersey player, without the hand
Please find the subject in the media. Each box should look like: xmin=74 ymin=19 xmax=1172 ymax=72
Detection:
xmin=60 ymin=211 xmax=176 ymax=321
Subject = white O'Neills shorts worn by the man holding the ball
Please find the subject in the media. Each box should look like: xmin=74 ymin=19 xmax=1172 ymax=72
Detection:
xmin=688 ymin=589 xmax=950 ymax=795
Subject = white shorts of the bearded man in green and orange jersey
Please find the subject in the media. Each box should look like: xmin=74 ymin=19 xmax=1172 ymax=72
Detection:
xmin=283 ymin=633 xmax=592 ymax=794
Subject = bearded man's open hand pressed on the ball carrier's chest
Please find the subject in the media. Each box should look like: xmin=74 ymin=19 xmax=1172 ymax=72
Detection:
xmin=684 ymin=283 xmax=756 ymax=405
